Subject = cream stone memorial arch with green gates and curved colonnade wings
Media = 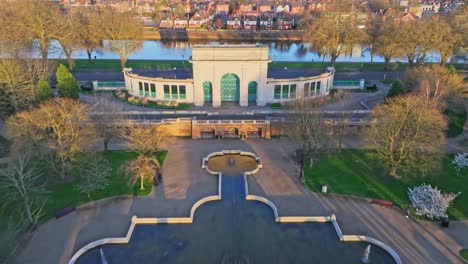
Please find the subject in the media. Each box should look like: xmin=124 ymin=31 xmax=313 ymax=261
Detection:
xmin=124 ymin=45 xmax=334 ymax=107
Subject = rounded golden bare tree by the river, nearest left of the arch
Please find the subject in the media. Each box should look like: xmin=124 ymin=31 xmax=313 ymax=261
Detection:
xmin=93 ymin=8 xmax=143 ymax=69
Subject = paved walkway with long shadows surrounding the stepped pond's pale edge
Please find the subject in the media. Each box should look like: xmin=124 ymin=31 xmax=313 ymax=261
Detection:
xmin=12 ymin=139 xmax=468 ymax=264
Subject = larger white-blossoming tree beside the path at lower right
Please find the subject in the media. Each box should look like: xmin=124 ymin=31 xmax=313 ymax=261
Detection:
xmin=408 ymin=184 xmax=460 ymax=219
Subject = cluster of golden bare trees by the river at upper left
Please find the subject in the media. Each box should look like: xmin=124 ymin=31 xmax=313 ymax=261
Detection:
xmin=0 ymin=0 xmax=143 ymax=115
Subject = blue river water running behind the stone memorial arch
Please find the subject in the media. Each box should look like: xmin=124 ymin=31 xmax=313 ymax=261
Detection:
xmin=43 ymin=40 xmax=440 ymax=62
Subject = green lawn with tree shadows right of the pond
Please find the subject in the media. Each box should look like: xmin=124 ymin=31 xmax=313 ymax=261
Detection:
xmin=304 ymin=150 xmax=468 ymax=219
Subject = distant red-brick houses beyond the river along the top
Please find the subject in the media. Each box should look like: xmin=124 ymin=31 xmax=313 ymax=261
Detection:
xmin=61 ymin=0 xmax=464 ymax=31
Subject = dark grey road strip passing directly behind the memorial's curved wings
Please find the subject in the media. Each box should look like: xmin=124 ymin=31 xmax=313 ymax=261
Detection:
xmin=73 ymin=69 xmax=403 ymax=82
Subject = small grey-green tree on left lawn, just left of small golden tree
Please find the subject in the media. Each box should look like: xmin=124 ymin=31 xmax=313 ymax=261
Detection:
xmin=75 ymin=155 xmax=112 ymax=198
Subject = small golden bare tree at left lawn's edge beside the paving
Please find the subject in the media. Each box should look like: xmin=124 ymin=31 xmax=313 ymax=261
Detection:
xmin=125 ymin=155 xmax=160 ymax=190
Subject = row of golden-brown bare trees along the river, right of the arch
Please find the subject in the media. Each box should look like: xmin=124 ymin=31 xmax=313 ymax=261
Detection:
xmin=302 ymin=3 xmax=468 ymax=70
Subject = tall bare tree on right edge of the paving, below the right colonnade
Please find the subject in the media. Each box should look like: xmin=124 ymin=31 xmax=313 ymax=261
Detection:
xmin=286 ymin=98 xmax=331 ymax=181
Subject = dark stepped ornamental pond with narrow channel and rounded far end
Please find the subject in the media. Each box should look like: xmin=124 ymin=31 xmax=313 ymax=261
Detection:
xmin=77 ymin=157 xmax=394 ymax=264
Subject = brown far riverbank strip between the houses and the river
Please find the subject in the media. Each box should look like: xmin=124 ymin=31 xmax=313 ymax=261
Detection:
xmin=143 ymin=28 xmax=305 ymax=42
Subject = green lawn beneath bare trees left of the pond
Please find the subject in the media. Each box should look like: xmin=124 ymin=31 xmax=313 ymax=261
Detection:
xmin=43 ymin=151 xmax=167 ymax=220
